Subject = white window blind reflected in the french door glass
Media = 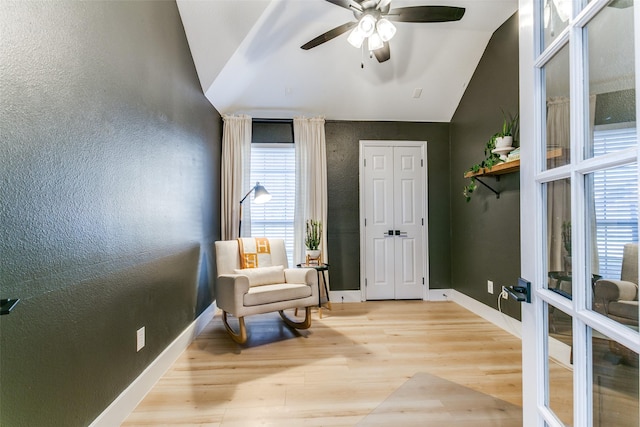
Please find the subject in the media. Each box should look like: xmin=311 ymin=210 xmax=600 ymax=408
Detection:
xmin=593 ymin=127 xmax=638 ymax=278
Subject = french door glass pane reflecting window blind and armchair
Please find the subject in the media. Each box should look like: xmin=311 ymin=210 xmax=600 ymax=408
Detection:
xmin=585 ymin=163 xmax=638 ymax=328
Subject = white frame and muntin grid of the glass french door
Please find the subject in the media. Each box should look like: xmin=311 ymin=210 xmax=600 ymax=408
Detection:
xmin=519 ymin=0 xmax=640 ymax=427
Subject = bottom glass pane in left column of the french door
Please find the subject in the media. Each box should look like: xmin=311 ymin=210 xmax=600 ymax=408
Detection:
xmin=547 ymin=305 xmax=573 ymax=426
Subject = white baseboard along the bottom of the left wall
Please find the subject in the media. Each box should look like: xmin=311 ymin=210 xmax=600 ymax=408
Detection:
xmin=90 ymin=302 xmax=217 ymax=427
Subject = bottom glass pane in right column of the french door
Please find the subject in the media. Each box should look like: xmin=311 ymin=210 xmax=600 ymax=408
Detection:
xmin=592 ymin=330 xmax=640 ymax=427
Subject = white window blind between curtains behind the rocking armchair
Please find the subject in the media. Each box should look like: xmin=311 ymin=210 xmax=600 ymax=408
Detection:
xmin=250 ymin=143 xmax=296 ymax=267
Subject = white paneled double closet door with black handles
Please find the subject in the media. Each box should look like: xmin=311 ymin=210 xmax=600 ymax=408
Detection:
xmin=360 ymin=141 xmax=426 ymax=300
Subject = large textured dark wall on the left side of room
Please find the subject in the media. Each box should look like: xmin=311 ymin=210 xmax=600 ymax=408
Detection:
xmin=0 ymin=1 xmax=222 ymax=427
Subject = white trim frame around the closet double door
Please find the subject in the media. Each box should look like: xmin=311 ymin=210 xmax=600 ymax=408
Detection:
xmin=358 ymin=140 xmax=429 ymax=301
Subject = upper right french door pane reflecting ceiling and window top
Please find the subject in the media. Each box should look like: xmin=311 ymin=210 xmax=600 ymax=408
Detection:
xmin=585 ymin=2 xmax=636 ymax=158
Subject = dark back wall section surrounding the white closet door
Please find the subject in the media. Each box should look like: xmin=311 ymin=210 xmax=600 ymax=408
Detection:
xmin=325 ymin=120 xmax=451 ymax=290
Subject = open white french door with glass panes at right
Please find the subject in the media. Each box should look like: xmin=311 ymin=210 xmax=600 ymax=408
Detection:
xmin=519 ymin=0 xmax=640 ymax=427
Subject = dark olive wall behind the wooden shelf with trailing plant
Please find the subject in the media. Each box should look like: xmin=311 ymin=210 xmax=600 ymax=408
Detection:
xmin=451 ymin=14 xmax=520 ymax=318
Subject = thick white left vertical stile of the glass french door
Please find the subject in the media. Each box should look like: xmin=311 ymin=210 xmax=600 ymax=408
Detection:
xmin=519 ymin=0 xmax=547 ymax=427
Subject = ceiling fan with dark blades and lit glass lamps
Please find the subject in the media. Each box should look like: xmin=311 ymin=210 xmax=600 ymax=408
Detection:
xmin=300 ymin=0 xmax=465 ymax=62
